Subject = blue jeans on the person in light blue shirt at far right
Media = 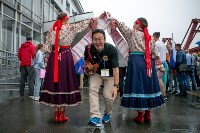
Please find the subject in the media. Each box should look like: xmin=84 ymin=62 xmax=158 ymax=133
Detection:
xmin=187 ymin=66 xmax=197 ymax=90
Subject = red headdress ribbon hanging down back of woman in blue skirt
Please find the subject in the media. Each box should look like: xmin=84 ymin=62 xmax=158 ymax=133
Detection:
xmin=136 ymin=19 xmax=151 ymax=77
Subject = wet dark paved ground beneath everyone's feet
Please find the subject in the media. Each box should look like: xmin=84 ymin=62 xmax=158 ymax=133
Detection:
xmin=0 ymin=90 xmax=200 ymax=133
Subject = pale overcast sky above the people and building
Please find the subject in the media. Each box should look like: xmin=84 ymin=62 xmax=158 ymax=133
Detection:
xmin=80 ymin=0 xmax=200 ymax=48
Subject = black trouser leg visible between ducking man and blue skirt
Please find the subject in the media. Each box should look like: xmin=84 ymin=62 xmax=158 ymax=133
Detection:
xmin=119 ymin=67 xmax=126 ymax=97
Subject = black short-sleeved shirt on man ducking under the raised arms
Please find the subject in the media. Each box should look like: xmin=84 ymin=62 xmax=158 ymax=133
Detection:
xmin=84 ymin=43 xmax=119 ymax=76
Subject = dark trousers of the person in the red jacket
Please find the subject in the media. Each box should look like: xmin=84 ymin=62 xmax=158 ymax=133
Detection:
xmin=20 ymin=66 xmax=35 ymax=96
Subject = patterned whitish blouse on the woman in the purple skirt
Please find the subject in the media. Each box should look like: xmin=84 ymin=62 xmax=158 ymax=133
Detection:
xmin=44 ymin=20 xmax=90 ymax=52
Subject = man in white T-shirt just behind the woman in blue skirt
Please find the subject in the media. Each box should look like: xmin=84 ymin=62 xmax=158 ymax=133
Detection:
xmin=153 ymin=32 xmax=168 ymax=91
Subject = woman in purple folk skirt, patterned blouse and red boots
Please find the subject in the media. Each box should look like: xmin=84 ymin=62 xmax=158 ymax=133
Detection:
xmin=39 ymin=12 xmax=94 ymax=122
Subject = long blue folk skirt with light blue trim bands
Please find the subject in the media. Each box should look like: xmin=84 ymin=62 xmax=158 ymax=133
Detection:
xmin=121 ymin=54 xmax=164 ymax=110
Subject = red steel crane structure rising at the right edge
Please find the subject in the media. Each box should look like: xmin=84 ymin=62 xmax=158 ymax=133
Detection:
xmin=181 ymin=18 xmax=200 ymax=53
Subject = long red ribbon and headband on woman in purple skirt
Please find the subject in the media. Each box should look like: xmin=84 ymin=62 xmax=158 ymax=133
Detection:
xmin=52 ymin=16 xmax=68 ymax=82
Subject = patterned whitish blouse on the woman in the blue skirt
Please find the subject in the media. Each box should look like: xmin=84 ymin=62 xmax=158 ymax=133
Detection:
xmin=118 ymin=22 xmax=158 ymax=56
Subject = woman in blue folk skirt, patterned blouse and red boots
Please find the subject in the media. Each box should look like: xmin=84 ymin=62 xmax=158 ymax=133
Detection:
xmin=112 ymin=18 xmax=164 ymax=123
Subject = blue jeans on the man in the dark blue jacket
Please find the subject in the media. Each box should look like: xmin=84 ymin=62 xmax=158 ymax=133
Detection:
xmin=177 ymin=72 xmax=188 ymax=95
